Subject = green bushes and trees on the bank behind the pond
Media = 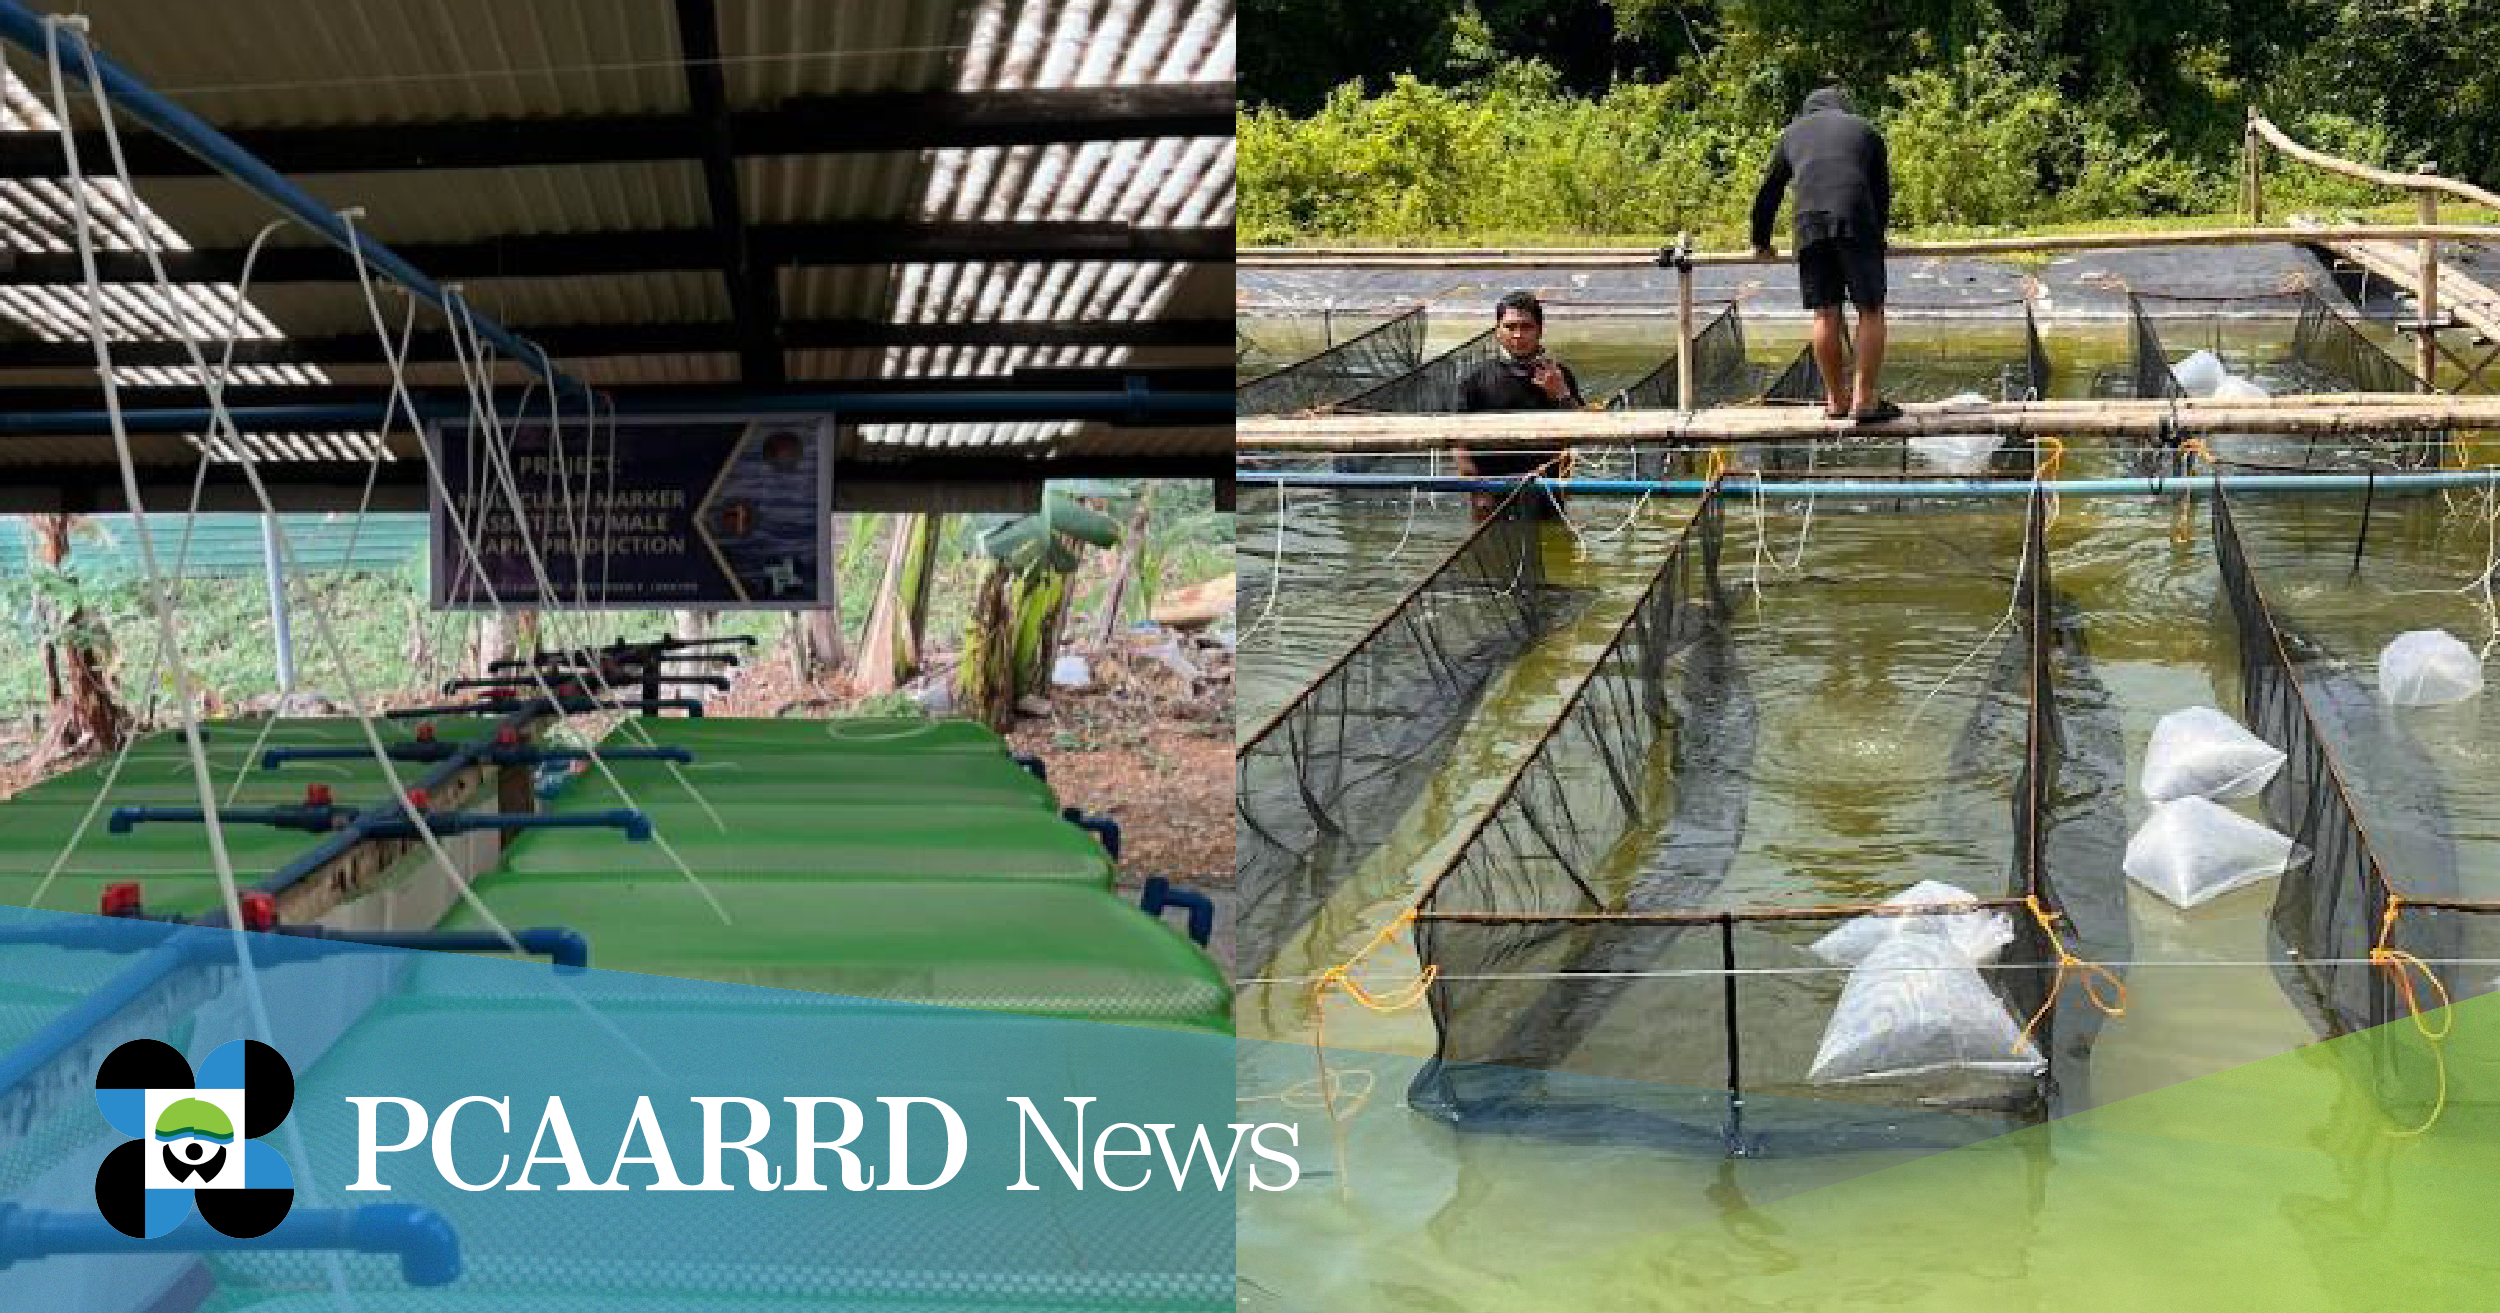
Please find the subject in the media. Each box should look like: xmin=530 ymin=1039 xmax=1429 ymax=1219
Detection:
xmin=1238 ymin=0 xmax=2500 ymax=248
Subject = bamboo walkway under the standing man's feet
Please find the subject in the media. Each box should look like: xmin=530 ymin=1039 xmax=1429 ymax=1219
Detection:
xmin=1235 ymin=393 xmax=2500 ymax=453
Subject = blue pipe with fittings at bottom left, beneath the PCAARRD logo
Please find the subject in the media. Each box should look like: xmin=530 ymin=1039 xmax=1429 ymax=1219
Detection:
xmin=0 ymin=1203 xmax=460 ymax=1285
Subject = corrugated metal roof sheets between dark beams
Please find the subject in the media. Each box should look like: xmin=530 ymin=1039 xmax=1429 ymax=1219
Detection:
xmin=0 ymin=0 xmax=1235 ymax=470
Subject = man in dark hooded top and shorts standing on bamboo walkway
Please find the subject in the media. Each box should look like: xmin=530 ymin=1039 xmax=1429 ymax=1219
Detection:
xmin=1753 ymin=88 xmax=1900 ymax=425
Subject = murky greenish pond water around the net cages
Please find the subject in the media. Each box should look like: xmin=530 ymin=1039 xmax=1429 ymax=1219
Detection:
xmin=1238 ymin=320 xmax=2500 ymax=1313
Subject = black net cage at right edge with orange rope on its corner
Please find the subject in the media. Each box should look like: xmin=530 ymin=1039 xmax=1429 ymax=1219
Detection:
xmin=2210 ymin=485 xmax=2500 ymax=1120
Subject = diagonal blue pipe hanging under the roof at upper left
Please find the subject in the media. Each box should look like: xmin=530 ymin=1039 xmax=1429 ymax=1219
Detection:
xmin=0 ymin=0 xmax=570 ymax=400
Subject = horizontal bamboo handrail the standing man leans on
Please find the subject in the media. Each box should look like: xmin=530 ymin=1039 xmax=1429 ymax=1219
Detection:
xmin=1233 ymin=223 xmax=2500 ymax=270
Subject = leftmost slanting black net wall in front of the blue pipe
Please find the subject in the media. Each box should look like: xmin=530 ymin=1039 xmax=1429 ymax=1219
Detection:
xmin=1233 ymin=480 xmax=1555 ymax=975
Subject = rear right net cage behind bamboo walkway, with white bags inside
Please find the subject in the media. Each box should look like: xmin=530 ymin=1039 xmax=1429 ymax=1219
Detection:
xmin=2093 ymin=283 xmax=2450 ymax=473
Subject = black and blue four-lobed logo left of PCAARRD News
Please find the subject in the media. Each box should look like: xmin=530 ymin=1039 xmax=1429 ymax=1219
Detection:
xmin=95 ymin=1040 xmax=295 ymax=1240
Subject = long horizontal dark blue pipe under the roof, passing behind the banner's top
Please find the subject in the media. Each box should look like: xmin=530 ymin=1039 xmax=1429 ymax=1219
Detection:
xmin=0 ymin=387 xmax=1233 ymax=438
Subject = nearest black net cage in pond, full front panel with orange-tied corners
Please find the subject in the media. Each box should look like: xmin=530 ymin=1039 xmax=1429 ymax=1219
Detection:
xmin=1408 ymin=485 xmax=2098 ymax=1155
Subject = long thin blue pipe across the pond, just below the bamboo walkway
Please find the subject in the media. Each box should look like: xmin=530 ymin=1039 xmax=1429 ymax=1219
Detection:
xmin=1233 ymin=470 xmax=2500 ymax=498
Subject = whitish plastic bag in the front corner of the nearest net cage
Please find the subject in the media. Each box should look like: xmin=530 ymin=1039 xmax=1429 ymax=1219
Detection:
xmin=1805 ymin=880 xmax=2048 ymax=1098
